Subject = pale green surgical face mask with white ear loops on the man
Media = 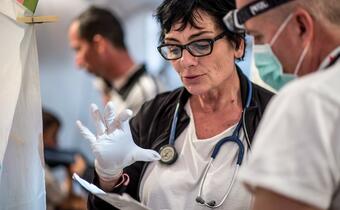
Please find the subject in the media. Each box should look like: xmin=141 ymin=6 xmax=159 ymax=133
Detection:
xmin=254 ymin=14 xmax=309 ymax=90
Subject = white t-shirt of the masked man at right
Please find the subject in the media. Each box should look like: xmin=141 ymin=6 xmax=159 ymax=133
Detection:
xmin=239 ymin=48 xmax=340 ymax=210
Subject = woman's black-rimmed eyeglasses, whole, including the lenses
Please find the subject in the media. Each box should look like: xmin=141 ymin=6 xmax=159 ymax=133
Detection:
xmin=157 ymin=31 xmax=226 ymax=60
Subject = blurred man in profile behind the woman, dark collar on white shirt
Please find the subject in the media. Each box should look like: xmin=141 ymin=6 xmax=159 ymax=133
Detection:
xmin=69 ymin=6 xmax=161 ymax=113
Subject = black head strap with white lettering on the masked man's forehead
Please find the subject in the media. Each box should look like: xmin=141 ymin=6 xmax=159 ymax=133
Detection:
xmin=237 ymin=0 xmax=292 ymax=24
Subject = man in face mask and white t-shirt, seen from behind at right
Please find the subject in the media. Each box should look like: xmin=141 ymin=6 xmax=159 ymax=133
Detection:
xmin=225 ymin=0 xmax=340 ymax=210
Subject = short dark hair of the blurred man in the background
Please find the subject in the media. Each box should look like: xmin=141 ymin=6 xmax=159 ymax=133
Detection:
xmin=75 ymin=6 xmax=126 ymax=49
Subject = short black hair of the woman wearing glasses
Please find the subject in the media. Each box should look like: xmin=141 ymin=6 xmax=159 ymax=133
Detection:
xmin=154 ymin=0 xmax=246 ymax=60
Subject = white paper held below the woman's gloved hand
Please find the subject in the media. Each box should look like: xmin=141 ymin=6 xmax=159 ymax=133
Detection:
xmin=73 ymin=174 xmax=151 ymax=210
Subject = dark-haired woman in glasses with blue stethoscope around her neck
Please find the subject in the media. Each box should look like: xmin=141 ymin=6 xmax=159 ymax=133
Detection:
xmin=81 ymin=0 xmax=272 ymax=210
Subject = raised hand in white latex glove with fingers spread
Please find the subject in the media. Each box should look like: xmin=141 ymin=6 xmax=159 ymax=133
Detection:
xmin=77 ymin=102 xmax=160 ymax=181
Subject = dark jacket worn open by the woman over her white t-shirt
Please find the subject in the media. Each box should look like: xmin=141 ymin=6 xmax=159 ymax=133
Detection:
xmin=88 ymin=70 xmax=273 ymax=210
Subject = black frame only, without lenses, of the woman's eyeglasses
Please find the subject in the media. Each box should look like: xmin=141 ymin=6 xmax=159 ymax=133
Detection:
xmin=157 ymin=31 xmax=227 ymax=60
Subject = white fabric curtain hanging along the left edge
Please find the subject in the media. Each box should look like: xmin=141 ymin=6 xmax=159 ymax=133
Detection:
xmin=0 ymin=0 xmax=46 ymax=210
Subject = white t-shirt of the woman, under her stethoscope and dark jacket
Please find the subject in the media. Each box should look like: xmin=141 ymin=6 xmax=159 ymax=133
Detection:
xmin=140 ymin=103 xmax=251 ymax=210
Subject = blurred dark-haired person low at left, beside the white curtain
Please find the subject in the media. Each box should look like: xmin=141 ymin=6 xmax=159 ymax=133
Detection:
xmin=43 ymin=110 xmax=87 ymax=210
